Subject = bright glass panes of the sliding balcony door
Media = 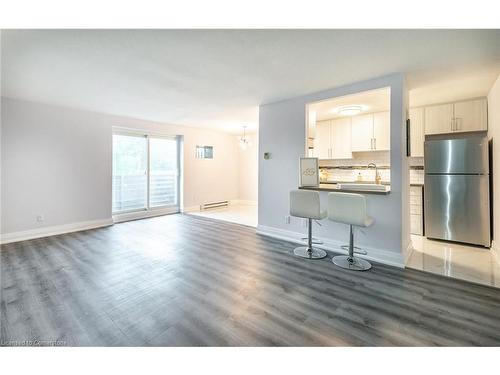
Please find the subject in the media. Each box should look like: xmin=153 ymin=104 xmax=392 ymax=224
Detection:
xmin=113 ymin=133 xmax=179 ymax=214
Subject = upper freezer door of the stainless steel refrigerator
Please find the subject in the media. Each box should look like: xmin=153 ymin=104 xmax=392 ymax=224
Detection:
xmin=424 ymin=136 xmax=489 ymax=174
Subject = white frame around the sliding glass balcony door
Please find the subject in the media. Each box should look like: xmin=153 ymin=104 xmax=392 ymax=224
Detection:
xmin=111 ymin=127 xmax=182 ymax=223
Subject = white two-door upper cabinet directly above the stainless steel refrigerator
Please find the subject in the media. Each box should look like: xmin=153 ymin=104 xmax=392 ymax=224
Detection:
xmin=425 ymin=98 xmax=488 ymax=134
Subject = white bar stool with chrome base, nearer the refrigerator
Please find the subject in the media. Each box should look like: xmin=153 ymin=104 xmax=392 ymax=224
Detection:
xmin=328 ymin=193 xmax=373 ymax=271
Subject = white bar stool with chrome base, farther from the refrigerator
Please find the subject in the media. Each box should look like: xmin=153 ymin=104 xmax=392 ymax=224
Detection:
xmin=290 ymin=190 xmax=326 ymax=259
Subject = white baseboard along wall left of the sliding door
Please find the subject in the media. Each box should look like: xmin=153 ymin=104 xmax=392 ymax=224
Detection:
xmin=0 ymin=218 xmax=113 ymax=244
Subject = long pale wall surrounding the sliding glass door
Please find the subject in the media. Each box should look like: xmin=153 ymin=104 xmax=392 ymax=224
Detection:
xmin=1 ymin=98 xmax=239 ymax=234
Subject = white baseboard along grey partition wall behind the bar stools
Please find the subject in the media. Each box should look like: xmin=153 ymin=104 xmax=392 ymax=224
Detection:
xmin=257 ymin=225 xmax=405 ymax=268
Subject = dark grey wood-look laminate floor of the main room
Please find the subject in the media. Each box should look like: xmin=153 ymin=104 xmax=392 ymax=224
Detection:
xmin=0 ymin=215 xmax=500 ymax=346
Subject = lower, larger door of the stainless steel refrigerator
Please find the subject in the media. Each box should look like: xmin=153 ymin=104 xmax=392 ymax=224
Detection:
xmin=424 ymin=175 xmax=490 ymax=247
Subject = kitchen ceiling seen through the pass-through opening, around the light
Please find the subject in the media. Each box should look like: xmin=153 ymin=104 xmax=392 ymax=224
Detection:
xmin=308 ymin=88 xmax=391 ymax=121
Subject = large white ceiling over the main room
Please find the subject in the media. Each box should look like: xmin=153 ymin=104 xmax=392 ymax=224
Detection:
xmin=1 ymin=30 xmax=500 ymax=133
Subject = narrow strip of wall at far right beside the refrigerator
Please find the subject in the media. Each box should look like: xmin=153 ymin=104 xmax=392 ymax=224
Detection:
xmin=488 ymin=76 xmax=500 ymax=248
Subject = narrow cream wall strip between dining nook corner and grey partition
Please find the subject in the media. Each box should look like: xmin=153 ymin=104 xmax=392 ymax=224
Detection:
xmin=239 ymin=134 xmax=259 ymax=203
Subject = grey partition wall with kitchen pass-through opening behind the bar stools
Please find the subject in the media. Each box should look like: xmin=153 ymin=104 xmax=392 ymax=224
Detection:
xmin=258 ymin=74 xmax=410 ymax=266
